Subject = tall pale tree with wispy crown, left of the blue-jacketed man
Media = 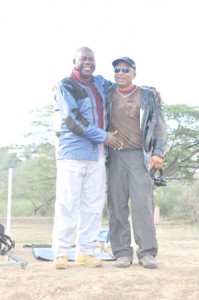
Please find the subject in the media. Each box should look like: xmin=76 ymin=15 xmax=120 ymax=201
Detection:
xmin=3 ymin=105 xmax=56 ymax=215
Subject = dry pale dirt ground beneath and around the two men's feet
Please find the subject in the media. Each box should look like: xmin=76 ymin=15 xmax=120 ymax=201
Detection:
xmin=0 ymin=218 xmax=199 ymax=300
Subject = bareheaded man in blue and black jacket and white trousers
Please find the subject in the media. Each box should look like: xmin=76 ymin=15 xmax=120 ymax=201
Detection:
xmin=52 ymin=47 xmax=122 ymax=269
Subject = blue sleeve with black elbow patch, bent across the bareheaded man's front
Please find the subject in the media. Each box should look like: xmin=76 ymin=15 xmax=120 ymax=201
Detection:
xmin=55 ymin=82 xmax=107 ymax=144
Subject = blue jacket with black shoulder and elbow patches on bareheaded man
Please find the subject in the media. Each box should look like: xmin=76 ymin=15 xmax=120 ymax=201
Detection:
xmin=55 ymin=75 xmax=113 ymax=161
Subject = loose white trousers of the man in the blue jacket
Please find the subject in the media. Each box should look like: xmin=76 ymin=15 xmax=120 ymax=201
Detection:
xmin=52 ymin=145 xmax=106 ymax=257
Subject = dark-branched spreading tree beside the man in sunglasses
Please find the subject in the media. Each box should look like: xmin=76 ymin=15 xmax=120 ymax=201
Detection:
xmin=164 ymin=105 xmax=199 ymax=181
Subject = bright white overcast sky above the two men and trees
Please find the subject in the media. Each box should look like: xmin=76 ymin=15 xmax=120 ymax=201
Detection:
xmin=0 ymin=0 xmax=199 ymax=146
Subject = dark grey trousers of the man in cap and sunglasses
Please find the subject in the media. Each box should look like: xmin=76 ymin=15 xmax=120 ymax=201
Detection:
xmin=108 ymin=149 xmax=158 ymax=258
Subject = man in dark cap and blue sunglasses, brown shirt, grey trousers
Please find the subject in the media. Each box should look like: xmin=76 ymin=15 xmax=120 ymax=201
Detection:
xmin=108 ymin=57 xmax=166 ymax=268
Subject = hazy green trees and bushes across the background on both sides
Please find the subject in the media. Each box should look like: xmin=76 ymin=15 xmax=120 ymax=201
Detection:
xmin=0 ymin=105 xmax=199 ymax=221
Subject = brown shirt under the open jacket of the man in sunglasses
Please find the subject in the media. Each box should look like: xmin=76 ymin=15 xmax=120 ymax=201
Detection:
xmin=110 ymin=87 xmax=142 ymax=149
